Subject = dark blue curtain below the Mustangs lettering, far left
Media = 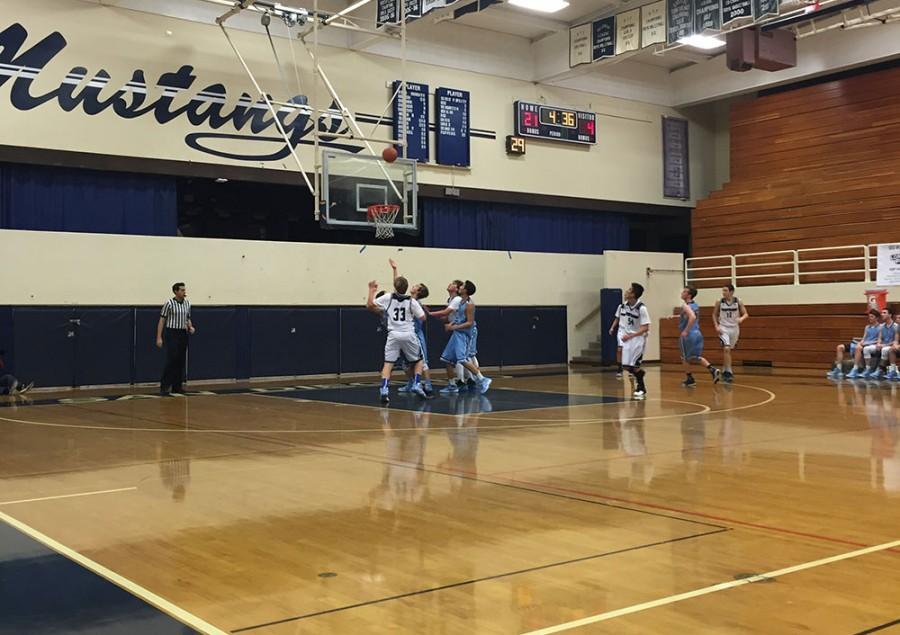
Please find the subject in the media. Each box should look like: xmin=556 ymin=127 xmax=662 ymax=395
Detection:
xmin=0 ymin=163 xmax=178 ymax=236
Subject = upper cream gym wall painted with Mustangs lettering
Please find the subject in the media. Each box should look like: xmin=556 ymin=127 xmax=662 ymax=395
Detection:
xmin=0 ymin=0 xmax=715 ymax=206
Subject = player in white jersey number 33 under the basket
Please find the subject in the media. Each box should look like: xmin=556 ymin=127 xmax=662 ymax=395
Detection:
xmin=366 ymin=276 xmax=425 ymax=404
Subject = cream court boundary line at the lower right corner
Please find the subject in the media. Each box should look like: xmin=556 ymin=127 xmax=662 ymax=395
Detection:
xmin=524 ymin=540 xmax=900 ymax=635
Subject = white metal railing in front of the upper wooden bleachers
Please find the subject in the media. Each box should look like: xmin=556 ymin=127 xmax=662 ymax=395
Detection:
xmin=684 ymin=245 xmax=878 ymax=288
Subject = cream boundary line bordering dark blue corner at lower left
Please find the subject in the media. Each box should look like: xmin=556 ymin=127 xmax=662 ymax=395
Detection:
xmin=0 ymin=511 xmax=228 ymax=635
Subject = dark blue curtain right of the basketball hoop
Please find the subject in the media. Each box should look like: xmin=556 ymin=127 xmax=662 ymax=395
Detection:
xmin=423 ymin=198 xmax=629 ymax=254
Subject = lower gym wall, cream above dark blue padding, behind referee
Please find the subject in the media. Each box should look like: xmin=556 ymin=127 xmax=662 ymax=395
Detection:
xmin=0 ymin=230 xmax=681 ymax=385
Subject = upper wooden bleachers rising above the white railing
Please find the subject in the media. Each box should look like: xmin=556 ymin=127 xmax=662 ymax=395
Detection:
xmin=692 ymin=68 xmax=900 ymax=260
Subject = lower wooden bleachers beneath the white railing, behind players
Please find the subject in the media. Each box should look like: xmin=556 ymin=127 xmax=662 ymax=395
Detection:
xmin=658 ymin=302 xmax=866 ymax=372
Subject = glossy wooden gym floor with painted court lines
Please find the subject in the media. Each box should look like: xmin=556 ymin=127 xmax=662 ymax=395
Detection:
xmin=0 ymin=368 xmax=900 ymax=635
